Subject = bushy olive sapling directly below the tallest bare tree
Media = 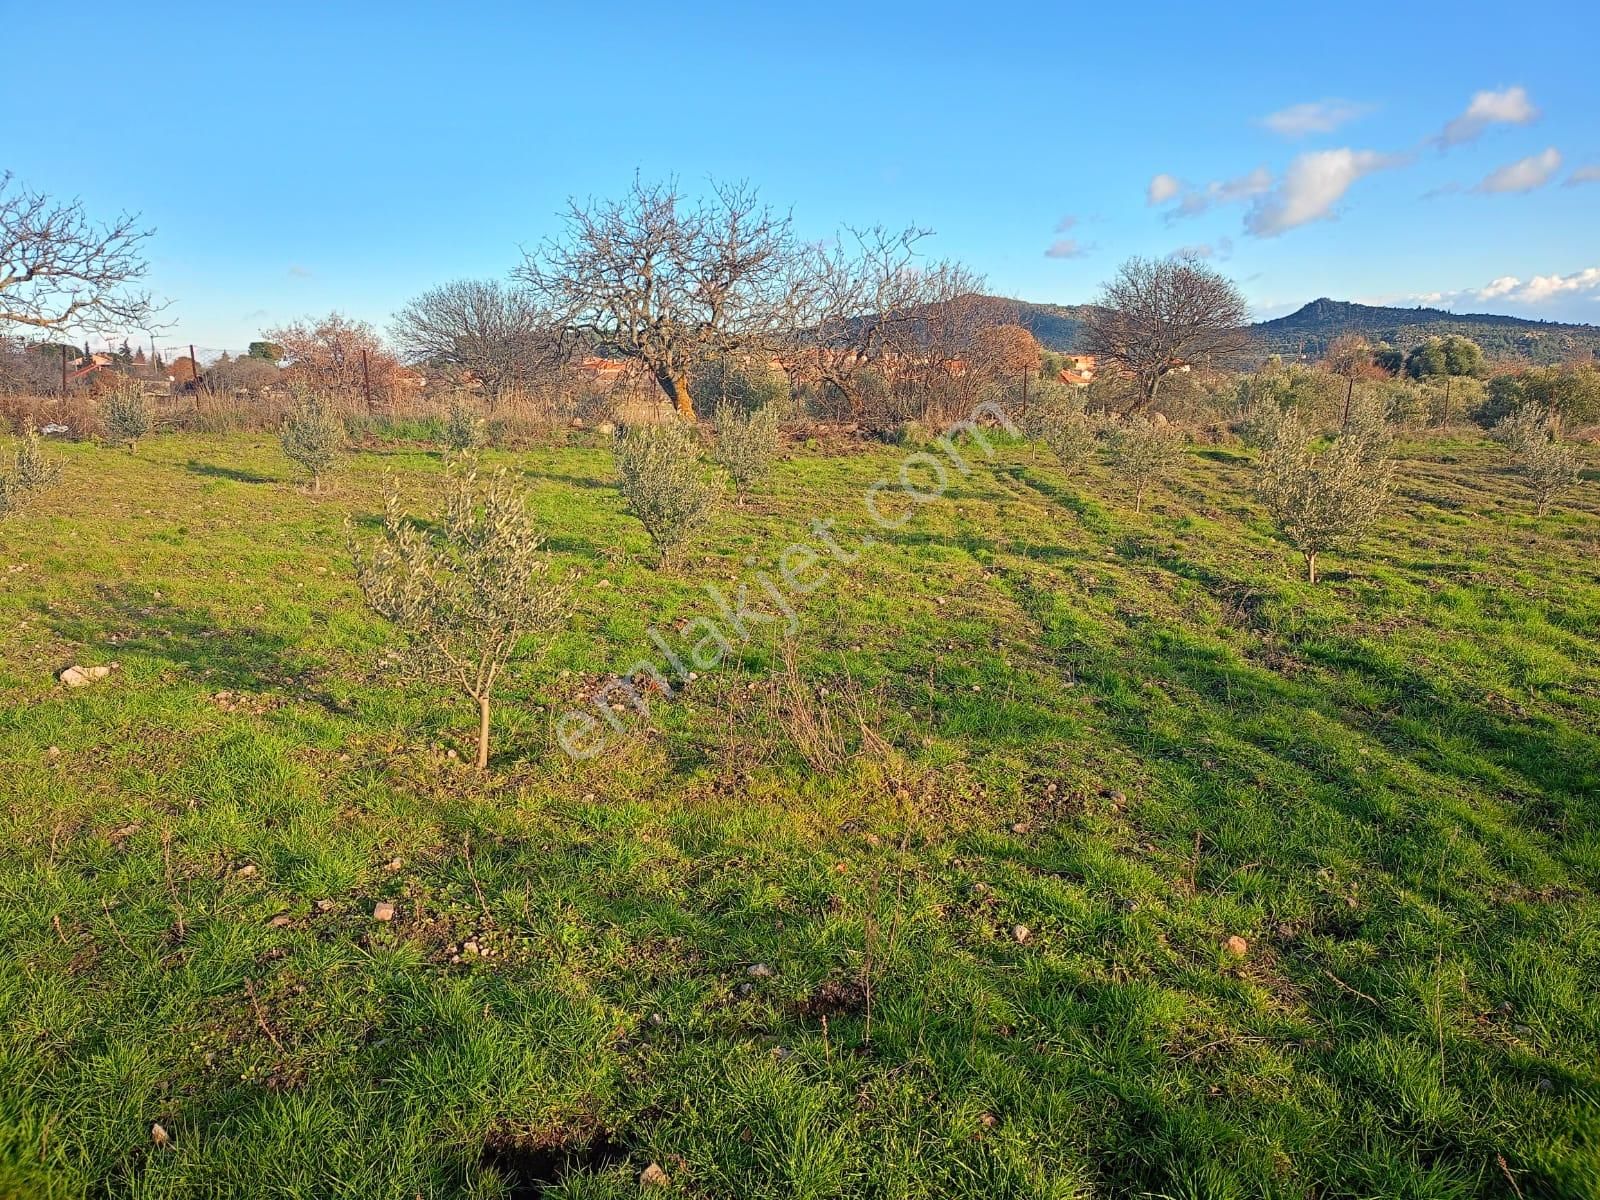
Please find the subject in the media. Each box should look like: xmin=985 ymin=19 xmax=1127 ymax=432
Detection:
xmin=613 ymin=422 xmax=717 ymax=566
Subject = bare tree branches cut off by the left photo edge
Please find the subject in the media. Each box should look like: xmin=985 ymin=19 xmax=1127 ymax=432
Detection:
xmin=0 ymin=171 xmax=157 ymax=331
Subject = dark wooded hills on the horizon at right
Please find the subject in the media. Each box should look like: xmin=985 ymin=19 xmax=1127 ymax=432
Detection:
xmin=1006 ymin=298 xmax=1600 ymax=363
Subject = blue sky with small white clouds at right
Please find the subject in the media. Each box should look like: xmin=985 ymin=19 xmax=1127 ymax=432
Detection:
xmin=0 ymin=0 xmax=1600 ymax=350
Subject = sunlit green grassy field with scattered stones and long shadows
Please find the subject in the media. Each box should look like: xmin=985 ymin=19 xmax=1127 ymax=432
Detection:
xmin=0 ymin=437 xmax=1600 ymax=1200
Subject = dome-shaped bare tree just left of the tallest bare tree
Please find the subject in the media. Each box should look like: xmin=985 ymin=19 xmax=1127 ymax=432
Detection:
xmin=390 ymin=280 xmax=563 ymax=397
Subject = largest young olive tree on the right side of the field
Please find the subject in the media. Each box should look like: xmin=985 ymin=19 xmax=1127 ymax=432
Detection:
xmin=1256 ymin=414 xmax=1394 ymax=582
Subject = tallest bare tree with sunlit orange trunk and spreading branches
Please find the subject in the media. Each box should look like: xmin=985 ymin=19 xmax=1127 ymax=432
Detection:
xmin=517 ymin=178 xmax=794 ymax=421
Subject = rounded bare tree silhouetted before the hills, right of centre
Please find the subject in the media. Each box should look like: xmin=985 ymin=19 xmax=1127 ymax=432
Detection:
xmin=1083 ymin=258 xmax=1250 ymax=413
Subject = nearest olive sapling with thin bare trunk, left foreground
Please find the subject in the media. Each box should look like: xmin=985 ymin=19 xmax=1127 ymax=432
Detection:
xmin=350 ymin=459 xmax=568 ymax=770
